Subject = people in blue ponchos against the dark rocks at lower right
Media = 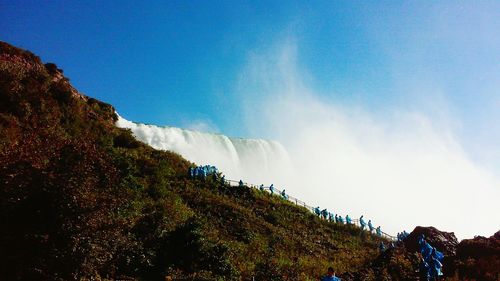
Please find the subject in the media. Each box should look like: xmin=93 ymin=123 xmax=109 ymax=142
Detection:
xmin=418 ymin=234 xmax=444 ymax=280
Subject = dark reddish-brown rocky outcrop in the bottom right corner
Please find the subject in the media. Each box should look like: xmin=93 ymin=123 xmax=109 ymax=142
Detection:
xmin=348 ymin=226 xmax=500 ymax=281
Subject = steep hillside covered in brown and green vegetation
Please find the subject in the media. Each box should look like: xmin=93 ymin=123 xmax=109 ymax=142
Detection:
xmin=0 ymin=42 xmax=386 ymax=280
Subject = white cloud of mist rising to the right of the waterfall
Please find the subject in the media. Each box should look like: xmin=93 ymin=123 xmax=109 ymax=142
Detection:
xmin=234 ymin=41 xmax=500 ymax=239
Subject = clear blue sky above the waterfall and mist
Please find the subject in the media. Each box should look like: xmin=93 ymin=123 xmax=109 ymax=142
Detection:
xmin=0 ymin=0 xmax=500 ymax=168
